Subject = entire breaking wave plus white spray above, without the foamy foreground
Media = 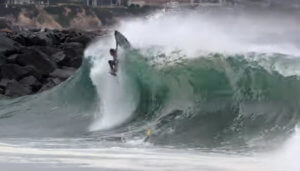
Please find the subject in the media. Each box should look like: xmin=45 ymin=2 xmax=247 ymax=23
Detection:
xmin=0 ymin=9 xmax=300 ymax=147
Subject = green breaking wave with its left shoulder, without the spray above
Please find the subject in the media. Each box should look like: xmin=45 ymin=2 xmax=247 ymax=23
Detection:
xmin=0 ymin=46 xmax=300 ymax=147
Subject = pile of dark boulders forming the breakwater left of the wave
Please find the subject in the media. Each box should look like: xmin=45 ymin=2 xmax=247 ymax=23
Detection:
xmin=0 ymin=30 xmax=97 ymax=97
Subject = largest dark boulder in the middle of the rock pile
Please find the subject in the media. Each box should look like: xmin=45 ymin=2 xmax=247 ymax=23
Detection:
xmin=16 ymin=49 xmax=57 ymax=74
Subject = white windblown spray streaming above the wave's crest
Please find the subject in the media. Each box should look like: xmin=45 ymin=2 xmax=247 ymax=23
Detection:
xmin=118 ymin=11 xmax=300 ymax=57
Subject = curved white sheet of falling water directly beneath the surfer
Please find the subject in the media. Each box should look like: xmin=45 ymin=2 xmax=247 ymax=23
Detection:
xmin=87 ymin=38 xmax=139 ymax=131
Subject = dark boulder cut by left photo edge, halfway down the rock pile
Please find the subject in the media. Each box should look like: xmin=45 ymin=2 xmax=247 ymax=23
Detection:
xmin=0 ymin=64 xmax=30 ymax=80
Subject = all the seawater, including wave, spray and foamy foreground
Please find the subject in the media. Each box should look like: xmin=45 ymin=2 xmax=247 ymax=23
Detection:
xmin=0 ymin=8 xmax=300 ymax=171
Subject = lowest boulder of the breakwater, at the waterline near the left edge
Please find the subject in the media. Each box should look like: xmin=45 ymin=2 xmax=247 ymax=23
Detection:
xmin=5 ymin=80 xmax=31 ymax=97
